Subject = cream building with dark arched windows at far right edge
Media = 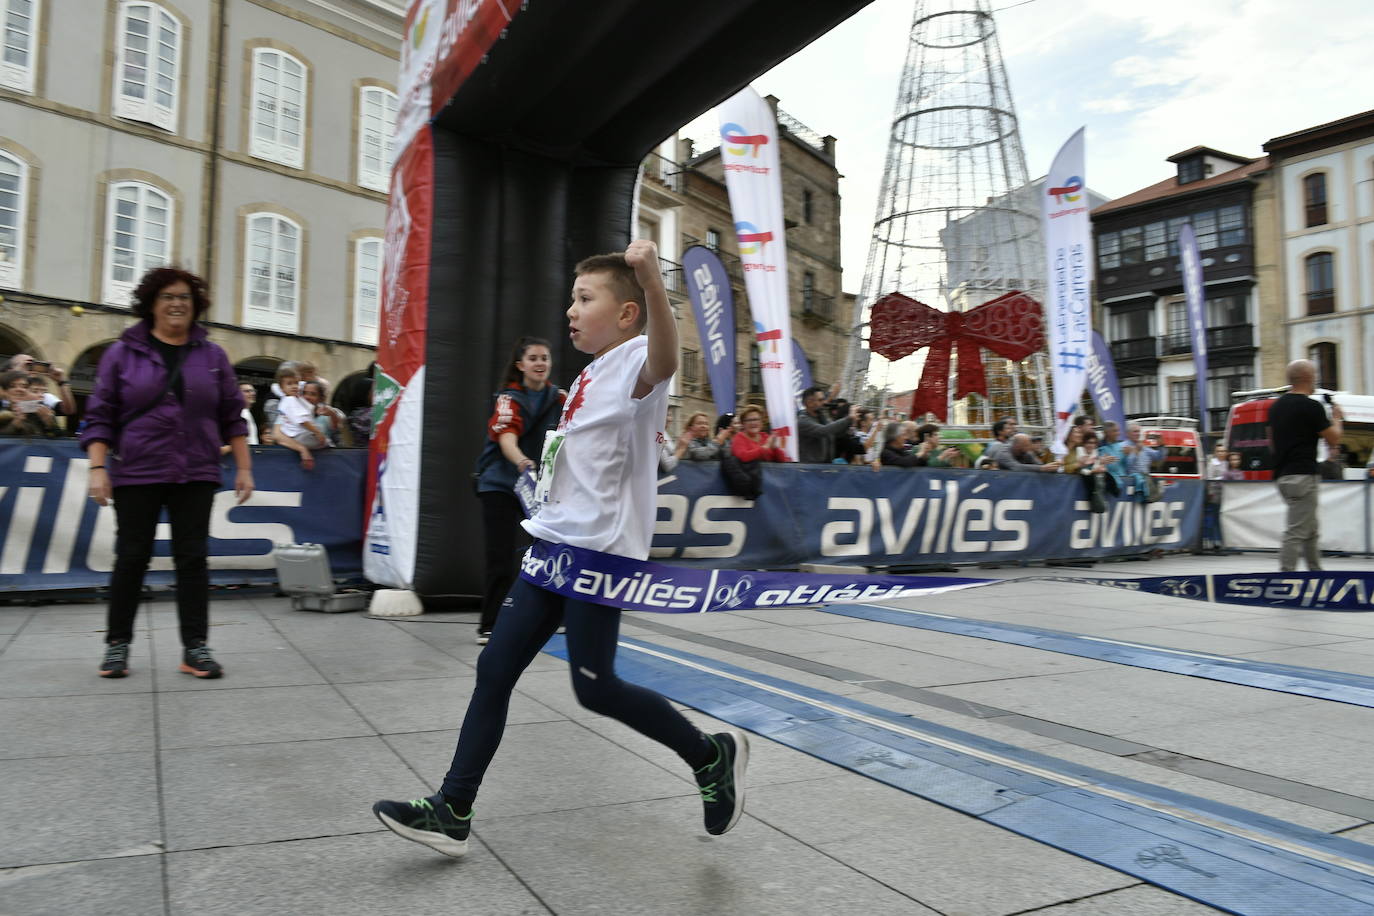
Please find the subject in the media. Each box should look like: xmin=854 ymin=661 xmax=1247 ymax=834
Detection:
xmin=1264 ymin=111 xmax=1374 ymax=394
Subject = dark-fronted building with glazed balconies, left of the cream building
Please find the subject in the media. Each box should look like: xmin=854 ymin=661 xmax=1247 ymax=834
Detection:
xmin=1092 ymin=147 xmax=1286 ymax=431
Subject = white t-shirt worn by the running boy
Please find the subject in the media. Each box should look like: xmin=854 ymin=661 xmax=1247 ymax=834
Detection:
xmin=522 ymin=336 xmax=668 ymax=560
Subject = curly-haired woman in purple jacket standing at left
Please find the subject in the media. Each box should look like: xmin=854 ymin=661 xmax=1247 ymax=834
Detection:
xmin=81 ymin=268 xmax=253 ymax=678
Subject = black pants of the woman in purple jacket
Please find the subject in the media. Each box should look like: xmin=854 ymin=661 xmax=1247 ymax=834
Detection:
xmin=106 ymin=482 xmax=218 ymax=648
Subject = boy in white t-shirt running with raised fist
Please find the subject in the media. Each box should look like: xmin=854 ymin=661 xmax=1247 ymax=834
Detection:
xmin=372 ymin=240 xmax=749 ymax=857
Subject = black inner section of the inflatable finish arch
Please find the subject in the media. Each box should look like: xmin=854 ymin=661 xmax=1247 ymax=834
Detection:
xmin=415 ymin=0 xmax=870 ymax=604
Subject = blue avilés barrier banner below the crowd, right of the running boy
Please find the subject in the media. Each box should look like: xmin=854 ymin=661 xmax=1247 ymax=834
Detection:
xmin=650 ymin=461 xmax=1202 ymax=569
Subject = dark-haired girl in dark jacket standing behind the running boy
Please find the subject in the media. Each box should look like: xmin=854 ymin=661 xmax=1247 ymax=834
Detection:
xmin=477 ymin=336 xmax=566 ymax=645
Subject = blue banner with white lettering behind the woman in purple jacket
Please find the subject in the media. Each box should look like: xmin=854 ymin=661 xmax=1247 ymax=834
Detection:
xmin=0 ymin=439 xmax=367 ymax=592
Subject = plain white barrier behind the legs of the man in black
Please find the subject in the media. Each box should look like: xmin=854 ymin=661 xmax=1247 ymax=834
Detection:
xmin=1221 ymin=481 xmax=1374 ymax=553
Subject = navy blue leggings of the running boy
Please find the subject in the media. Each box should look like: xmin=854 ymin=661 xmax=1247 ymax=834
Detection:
xmin=441 ymin=580 xmax=710 ymax=803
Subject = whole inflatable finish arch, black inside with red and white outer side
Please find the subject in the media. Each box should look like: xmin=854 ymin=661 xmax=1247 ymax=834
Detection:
xmin=364 ymin=0 xmax=868 ymax=606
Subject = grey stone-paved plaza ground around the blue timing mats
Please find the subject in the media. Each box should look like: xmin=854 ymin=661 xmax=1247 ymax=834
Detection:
xmin=0 ymin=555 xmax=1374 ymax=916
